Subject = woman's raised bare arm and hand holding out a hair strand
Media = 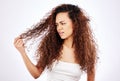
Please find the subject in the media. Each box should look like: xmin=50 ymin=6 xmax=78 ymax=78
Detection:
xmin=14 ymin=37 xmax=42 ymax=79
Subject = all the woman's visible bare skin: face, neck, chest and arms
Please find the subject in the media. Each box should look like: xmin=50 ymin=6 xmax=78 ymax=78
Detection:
xmin=14 ymin=12 xmax=95 ymax=81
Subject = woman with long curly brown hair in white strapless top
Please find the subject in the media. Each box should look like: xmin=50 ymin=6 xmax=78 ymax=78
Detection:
xmin=14 ymin=4 xmax=97 ymax=81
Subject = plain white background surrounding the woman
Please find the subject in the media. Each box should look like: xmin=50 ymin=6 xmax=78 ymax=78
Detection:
xmin=0 ymin=0 xmax=120 ymax=81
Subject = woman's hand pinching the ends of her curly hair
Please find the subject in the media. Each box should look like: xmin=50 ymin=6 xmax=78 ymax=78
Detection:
xmin=14 ymin=36 xmax=25 ymax=53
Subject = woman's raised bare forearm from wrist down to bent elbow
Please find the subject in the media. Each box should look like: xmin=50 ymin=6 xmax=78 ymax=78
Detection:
xmin=21 ymin=52 xmax=42 ymax=78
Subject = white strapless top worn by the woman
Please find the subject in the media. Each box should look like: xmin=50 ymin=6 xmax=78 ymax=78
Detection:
xmin=47 ymin=61 xmax=82 ymax=81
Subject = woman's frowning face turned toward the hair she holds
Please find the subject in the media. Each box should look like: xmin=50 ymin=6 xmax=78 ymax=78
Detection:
xmin=56 ymin=12 xmax=73 ymax=39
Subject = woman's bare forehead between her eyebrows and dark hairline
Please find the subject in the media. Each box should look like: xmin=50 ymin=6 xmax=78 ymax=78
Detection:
xmin=55 ymin=12 xmax=71 ymax=23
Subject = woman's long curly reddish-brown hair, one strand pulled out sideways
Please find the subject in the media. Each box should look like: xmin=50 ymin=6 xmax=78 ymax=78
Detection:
xmin=20 ymin=4 xmax=97 ymax=73
